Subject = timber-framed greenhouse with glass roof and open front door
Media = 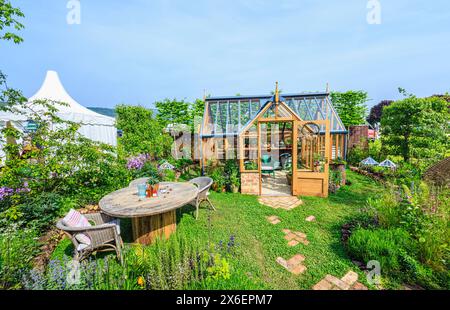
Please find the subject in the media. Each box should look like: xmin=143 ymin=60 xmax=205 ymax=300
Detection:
xmin=200 ymin=83 xmax=348 ymax=197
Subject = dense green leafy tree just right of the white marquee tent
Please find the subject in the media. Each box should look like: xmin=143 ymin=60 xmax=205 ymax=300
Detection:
xmin=116 ymin=105 xmax=172 ymax=159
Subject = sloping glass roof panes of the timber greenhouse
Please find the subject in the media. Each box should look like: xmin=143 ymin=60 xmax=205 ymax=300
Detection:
xmin=201 ymin=93 xmax=347 ymax=137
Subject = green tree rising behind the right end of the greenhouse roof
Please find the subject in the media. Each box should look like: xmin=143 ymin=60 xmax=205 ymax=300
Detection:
xmin=330 ymin=90 xmax=368 ymax=128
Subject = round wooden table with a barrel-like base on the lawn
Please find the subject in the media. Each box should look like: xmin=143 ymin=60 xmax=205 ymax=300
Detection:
xmin=99 ymin=179 xmax=198 ymax=244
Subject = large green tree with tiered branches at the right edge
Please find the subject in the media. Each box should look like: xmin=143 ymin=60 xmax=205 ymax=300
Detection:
xmin=381 ymin=95 xmax=450 ymax=163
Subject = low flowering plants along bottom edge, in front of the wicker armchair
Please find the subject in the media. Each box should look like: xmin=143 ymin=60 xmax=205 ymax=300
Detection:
xmin=23 ymin=235 xmax=235 ymax=290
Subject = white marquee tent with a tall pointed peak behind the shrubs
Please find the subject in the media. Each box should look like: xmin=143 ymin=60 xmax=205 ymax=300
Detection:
xmin=0 ymin=71 xmax=117 ymax=159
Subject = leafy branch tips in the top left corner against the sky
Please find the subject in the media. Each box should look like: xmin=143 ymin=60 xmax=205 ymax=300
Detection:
xmin=0 ymin=0 xmax=25 ymax=44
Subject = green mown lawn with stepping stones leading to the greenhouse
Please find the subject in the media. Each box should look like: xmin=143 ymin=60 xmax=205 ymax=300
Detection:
xmin=53 ymin=172 xmax=382 ymax=290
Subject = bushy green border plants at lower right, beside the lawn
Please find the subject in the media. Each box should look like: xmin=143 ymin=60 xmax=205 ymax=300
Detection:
xmin=348 ymin=183 xmax=450 ymax=288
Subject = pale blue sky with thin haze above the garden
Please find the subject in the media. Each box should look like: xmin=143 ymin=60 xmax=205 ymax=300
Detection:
xmin=0 ymin=0 xmax=450 ymax=107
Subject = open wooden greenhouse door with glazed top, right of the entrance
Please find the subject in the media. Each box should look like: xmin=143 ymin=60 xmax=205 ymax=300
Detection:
xmin=292 ymin=120 xmax=331 ymax=197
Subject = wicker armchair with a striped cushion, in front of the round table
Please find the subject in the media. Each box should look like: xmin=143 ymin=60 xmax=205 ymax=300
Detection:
xmin=56 ymin=213 xmax=123 ymax=264
